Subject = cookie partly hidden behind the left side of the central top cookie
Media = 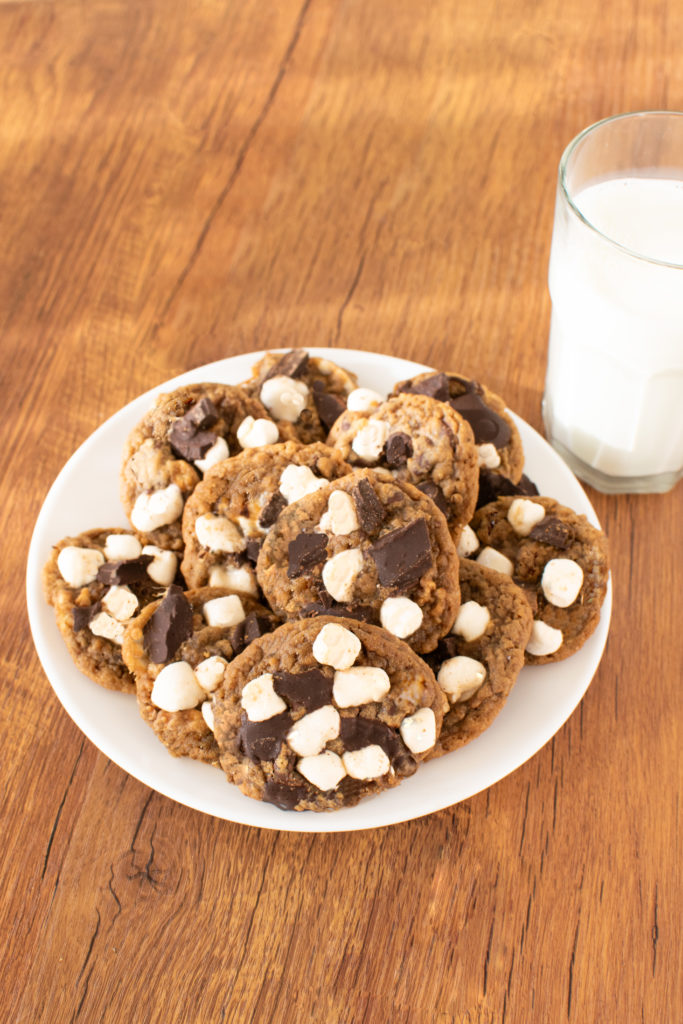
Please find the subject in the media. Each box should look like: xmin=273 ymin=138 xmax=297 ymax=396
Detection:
xmin=182 ymin=441 xmax=350 ymax=597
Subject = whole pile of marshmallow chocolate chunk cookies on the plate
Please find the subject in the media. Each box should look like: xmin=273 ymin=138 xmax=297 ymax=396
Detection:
xmin=43 ymin=349 xmax=608 ymax=811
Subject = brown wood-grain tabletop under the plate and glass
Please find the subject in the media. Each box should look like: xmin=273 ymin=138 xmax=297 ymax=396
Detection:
xmin=0 ymin=0 xmax=683 ymax=1024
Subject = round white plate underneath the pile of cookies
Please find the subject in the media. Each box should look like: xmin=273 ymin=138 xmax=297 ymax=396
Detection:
xmin=27 ymin=349 xmax=611 ymax=833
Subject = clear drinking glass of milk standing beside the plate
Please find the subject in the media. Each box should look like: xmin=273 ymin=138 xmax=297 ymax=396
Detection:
xmin=543 ymin=111 xmax=683 ymax=493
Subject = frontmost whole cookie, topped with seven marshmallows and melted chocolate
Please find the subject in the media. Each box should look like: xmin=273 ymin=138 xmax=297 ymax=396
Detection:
xmin=214 ymin=616 xmax=444 ymax=811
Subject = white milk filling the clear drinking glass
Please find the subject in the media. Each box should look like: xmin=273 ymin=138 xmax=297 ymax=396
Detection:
xmin=544 ymin=177 xmax=683 ymax=489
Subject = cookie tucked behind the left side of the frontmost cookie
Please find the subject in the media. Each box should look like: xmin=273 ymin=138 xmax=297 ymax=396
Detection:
xmin=123 ymin=587 xmax=278 ymax=765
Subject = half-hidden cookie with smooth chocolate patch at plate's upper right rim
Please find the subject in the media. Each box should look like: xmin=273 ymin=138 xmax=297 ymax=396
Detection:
xmin=393 ymin=373 xmax=524 ymax=483
